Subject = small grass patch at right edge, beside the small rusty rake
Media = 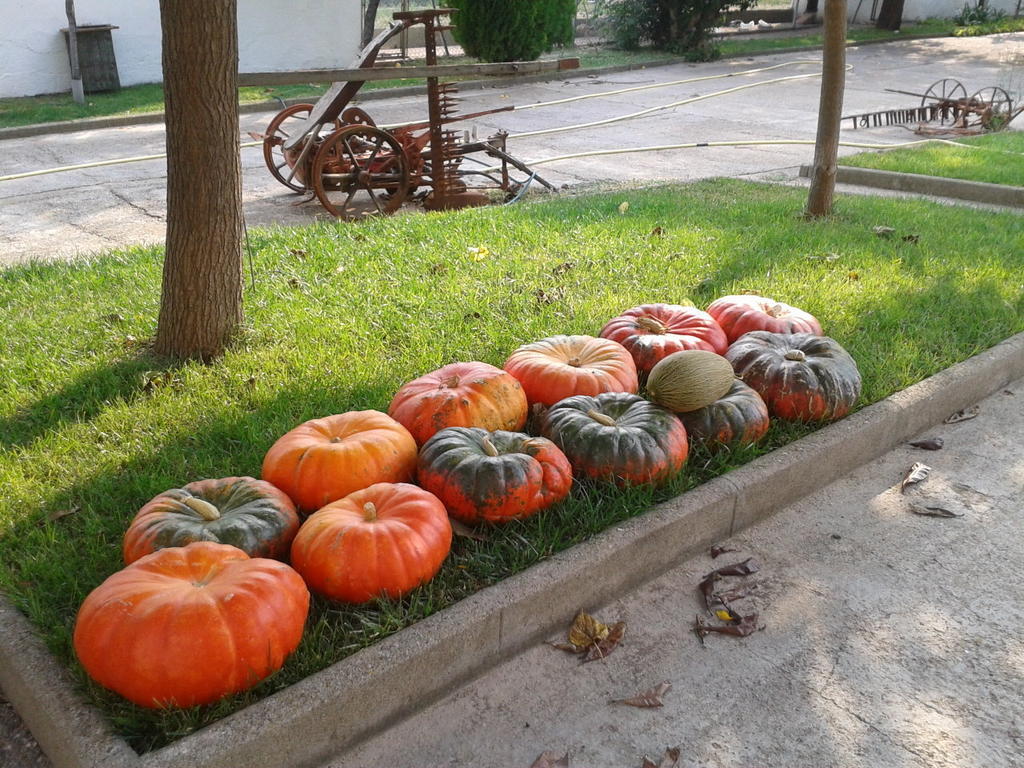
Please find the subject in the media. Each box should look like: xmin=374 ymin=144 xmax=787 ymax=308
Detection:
xmin=839 ymin=131 xmax=1024 ymax=186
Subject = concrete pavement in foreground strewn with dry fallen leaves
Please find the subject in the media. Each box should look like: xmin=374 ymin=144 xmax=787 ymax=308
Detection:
xmin=324 ymin=380 xmax=1024 ymax=768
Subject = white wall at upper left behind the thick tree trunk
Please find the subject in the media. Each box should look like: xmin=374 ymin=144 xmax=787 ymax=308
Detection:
xmin=0 ymin=0 xmax=359 ymax=97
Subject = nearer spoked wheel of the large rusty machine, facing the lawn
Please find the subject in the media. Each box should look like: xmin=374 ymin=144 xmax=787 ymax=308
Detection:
xmin=311 ymin=125 xmax=410 ymax=221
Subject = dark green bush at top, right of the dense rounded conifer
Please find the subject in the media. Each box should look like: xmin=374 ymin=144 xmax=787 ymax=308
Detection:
xmin=607 ymin=0 xmax=756 ymax=61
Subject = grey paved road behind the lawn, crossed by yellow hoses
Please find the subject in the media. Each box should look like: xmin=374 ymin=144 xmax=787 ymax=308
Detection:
xmin=0 ymin=33 xmax=1024 ymax=264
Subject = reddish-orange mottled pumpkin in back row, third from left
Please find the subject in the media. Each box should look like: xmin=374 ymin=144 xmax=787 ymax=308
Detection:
xmin=387 ymin=361 xmax=528 ymax=445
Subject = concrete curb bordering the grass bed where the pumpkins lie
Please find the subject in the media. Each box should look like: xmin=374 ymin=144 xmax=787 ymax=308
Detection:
xmin=0 ymin=333 xmax=1024 ymax=768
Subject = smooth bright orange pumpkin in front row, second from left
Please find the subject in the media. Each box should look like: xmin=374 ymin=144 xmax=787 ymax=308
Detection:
xmin=292 ymin=482 xmax=452 ymax=603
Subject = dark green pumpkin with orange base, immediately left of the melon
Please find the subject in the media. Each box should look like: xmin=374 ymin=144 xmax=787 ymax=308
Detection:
xmin=540 ymin=392 xmax=689 ymax=485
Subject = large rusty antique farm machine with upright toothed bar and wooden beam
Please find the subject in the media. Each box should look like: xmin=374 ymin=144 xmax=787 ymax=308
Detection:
xmin=258 ymin=8 xmax=579 ymax=220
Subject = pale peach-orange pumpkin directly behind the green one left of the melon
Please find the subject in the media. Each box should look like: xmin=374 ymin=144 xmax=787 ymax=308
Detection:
xmin=505 ymin=336 xmax=639 ymax=406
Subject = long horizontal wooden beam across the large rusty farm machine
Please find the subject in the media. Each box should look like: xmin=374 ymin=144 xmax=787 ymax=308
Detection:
xmin=239 ymin=58 xmax=580 ymax=86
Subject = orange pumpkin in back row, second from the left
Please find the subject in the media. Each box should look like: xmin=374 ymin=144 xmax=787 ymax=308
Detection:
xmin=262 ymin=411 xmax=417 ymax=512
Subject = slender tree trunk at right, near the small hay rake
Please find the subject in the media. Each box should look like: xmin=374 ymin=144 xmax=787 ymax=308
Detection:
xmin=804 ymin=0 xmax=846 ymax=218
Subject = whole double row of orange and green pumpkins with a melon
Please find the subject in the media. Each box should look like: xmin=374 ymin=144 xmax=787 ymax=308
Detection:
xmin=74 ymin=295 xmax=860 ymax=707
